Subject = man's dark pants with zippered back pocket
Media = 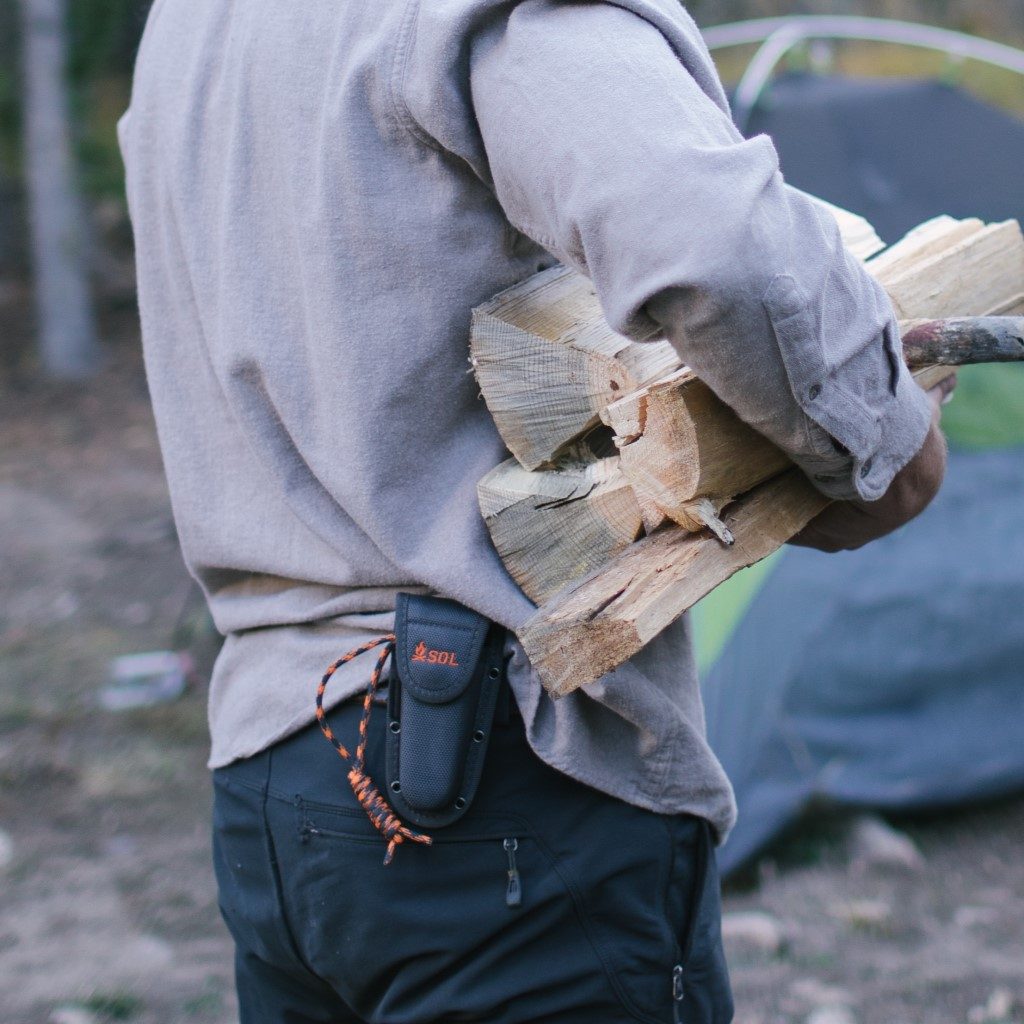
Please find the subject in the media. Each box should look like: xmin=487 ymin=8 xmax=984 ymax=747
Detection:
xmin=214 ymin=679 xmax=732 ymax=1024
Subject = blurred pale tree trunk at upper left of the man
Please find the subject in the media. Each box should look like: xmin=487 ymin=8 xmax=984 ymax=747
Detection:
xmin=22 ymin=0 xmax=99 ymax=379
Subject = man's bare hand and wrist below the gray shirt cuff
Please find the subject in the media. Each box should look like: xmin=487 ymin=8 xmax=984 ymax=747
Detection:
xmin=790 ymin=373 xmax=956 ymax=552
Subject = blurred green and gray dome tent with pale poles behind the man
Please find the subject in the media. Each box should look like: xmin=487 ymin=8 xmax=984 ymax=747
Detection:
xmin=693 ymin=18 xmax=1024 ymax=871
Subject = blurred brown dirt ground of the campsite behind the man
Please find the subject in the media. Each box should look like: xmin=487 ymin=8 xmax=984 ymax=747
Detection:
xmin=0 ymin=299 xmax=1024 ymax=1024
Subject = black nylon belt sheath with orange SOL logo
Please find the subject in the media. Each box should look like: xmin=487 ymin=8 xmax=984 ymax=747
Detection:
xmin=386 ymin=593 xmax=505 ymax=828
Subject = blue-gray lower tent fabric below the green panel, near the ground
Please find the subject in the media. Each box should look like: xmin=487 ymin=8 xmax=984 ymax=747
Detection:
xmin=703 ymin=449 xmax=1024 ymax=871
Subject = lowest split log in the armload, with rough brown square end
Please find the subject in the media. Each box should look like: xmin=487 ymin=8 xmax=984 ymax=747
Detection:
xmin=518 ymin=470 xmax=828 ymax=696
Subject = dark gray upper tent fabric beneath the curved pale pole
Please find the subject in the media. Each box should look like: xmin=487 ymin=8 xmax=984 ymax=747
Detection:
xmin=748 ymin=73 xmax=1024 ymax=244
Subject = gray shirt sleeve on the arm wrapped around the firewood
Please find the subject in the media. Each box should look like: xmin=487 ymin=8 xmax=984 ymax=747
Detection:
xmin=460 ymin=0 xmax=931 ymax=501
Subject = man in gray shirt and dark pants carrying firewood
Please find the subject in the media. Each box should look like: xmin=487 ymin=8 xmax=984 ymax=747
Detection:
xmin=121 ymin=0 xmax=944 ymax=1024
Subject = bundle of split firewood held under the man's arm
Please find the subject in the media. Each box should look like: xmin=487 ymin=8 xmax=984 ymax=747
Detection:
xmin=471 ymin=197 xmax=1024 ymax=695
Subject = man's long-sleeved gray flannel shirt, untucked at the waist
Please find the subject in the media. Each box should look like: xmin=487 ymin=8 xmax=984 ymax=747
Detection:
xmin=120 ymin=0 xmax=929 ymax=835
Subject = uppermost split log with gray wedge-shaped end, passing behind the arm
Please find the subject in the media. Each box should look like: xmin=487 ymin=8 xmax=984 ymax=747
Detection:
xmin=470 ymin=197 xmax=880 ymax=469
